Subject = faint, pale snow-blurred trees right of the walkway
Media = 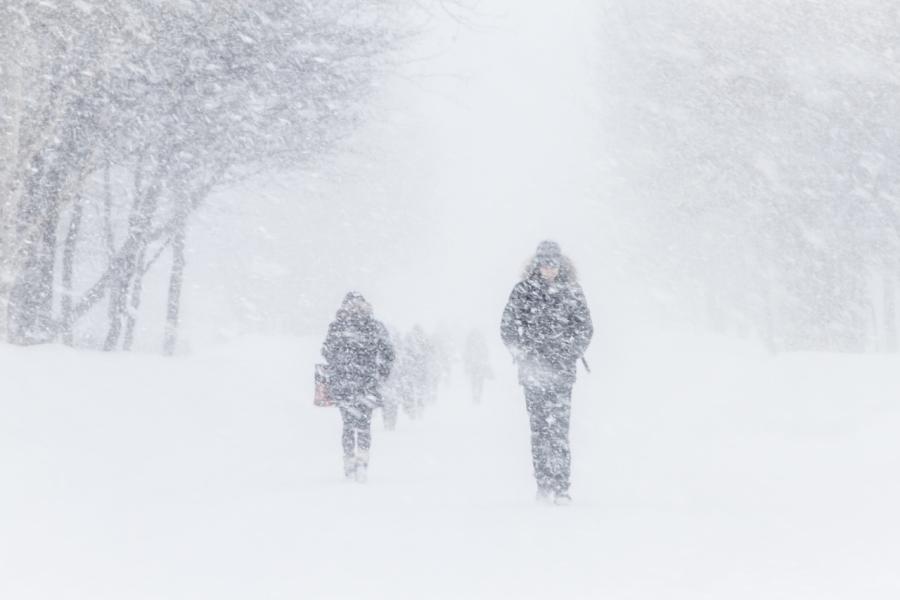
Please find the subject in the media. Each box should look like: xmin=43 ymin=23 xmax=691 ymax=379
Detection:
xmin=597 ymin=0 xmax=900 ymax=352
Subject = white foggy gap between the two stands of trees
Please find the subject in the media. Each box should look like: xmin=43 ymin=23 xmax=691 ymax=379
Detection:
xmin=180 ymin=2 xmax=608 ymax=350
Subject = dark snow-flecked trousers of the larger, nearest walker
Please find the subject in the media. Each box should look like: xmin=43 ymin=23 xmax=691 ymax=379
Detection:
xmin=525 ymin=383 xmax=572 ymax=494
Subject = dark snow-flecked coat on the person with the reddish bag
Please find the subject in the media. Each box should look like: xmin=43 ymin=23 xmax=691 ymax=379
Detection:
xmin=322 ymin=308 xmax=394 ymax=404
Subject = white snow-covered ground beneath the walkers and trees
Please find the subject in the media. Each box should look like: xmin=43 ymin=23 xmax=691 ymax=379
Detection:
xmin=0 ymin=339 xmax=900 ymax=600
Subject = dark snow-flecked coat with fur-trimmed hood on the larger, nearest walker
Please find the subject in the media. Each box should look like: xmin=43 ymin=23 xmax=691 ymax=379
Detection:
xmin=500 ymin=263 xmax=594 ymax=385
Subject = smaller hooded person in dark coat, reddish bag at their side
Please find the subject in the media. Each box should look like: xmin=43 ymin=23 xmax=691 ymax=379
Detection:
xmin=322 ymin=292 xmax=394 ymax=482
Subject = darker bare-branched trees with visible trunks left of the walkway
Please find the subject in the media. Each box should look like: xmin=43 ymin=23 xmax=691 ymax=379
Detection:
xmin=0 ymin=0 xmax=411 ymax=352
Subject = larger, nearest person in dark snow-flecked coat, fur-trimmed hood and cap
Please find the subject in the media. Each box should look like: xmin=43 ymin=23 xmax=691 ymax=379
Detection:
xmin=500 ymin=241 xmax=594 ymax=504
